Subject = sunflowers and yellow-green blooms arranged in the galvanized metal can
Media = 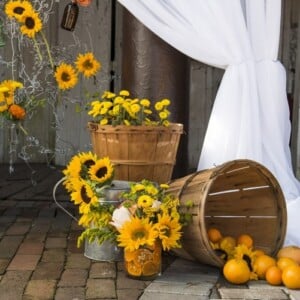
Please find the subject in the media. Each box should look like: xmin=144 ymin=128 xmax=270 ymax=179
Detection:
xmin=63 ymin=152 xmax=116 ymax=246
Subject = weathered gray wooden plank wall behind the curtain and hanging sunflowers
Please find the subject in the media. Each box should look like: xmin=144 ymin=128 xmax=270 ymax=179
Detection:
xmin=0 ymin=0 xmax=300 ymax=180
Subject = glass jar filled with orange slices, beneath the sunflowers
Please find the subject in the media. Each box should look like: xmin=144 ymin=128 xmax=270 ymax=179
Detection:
xmin=124 ymin=241 xmax=162 ymax=280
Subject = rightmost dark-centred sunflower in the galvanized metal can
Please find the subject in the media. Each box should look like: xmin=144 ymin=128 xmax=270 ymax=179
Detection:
xmin=89 ymin=157 xmax=113 ymax=183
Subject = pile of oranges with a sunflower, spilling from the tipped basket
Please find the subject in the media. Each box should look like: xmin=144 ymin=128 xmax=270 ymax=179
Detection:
xmin=207 ymin=228 xmax=300 ymax=289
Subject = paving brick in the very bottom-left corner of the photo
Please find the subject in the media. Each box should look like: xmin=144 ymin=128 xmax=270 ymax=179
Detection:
xmin=0 ymin=271 xmax=31 ymax=300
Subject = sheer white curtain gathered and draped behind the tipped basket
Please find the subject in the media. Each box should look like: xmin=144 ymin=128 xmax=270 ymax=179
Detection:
xmin=119 ymin=0 xmax=300 ymax=244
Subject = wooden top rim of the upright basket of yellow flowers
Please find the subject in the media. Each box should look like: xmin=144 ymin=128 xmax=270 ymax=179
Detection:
xmin=88 ymin=122 xmax=183 ymax=134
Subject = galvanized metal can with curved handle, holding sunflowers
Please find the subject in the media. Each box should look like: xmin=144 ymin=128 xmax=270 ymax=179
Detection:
xmin=53 ymin=178 xmax=130 ymax=261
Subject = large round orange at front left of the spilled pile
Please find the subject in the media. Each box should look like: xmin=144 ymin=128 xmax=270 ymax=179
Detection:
xmin=223 ymin=258 xmax=251 ymax=284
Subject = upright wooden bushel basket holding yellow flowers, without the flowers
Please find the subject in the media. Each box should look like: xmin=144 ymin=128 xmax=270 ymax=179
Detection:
xmin=88 ymin=122 xmax=183 ymax=183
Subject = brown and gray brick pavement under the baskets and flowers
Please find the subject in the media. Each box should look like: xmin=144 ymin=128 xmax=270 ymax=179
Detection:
xmin=0 ymin=164 xmax=300 ymax=300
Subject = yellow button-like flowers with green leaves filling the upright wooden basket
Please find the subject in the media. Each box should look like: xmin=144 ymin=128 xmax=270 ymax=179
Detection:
xmin=88 ymin=90 xmax=171 ymax=126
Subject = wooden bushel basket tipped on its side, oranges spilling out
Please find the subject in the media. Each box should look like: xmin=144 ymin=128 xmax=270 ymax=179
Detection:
xmin=169 ymin=160 xmax=287 ymax=267
